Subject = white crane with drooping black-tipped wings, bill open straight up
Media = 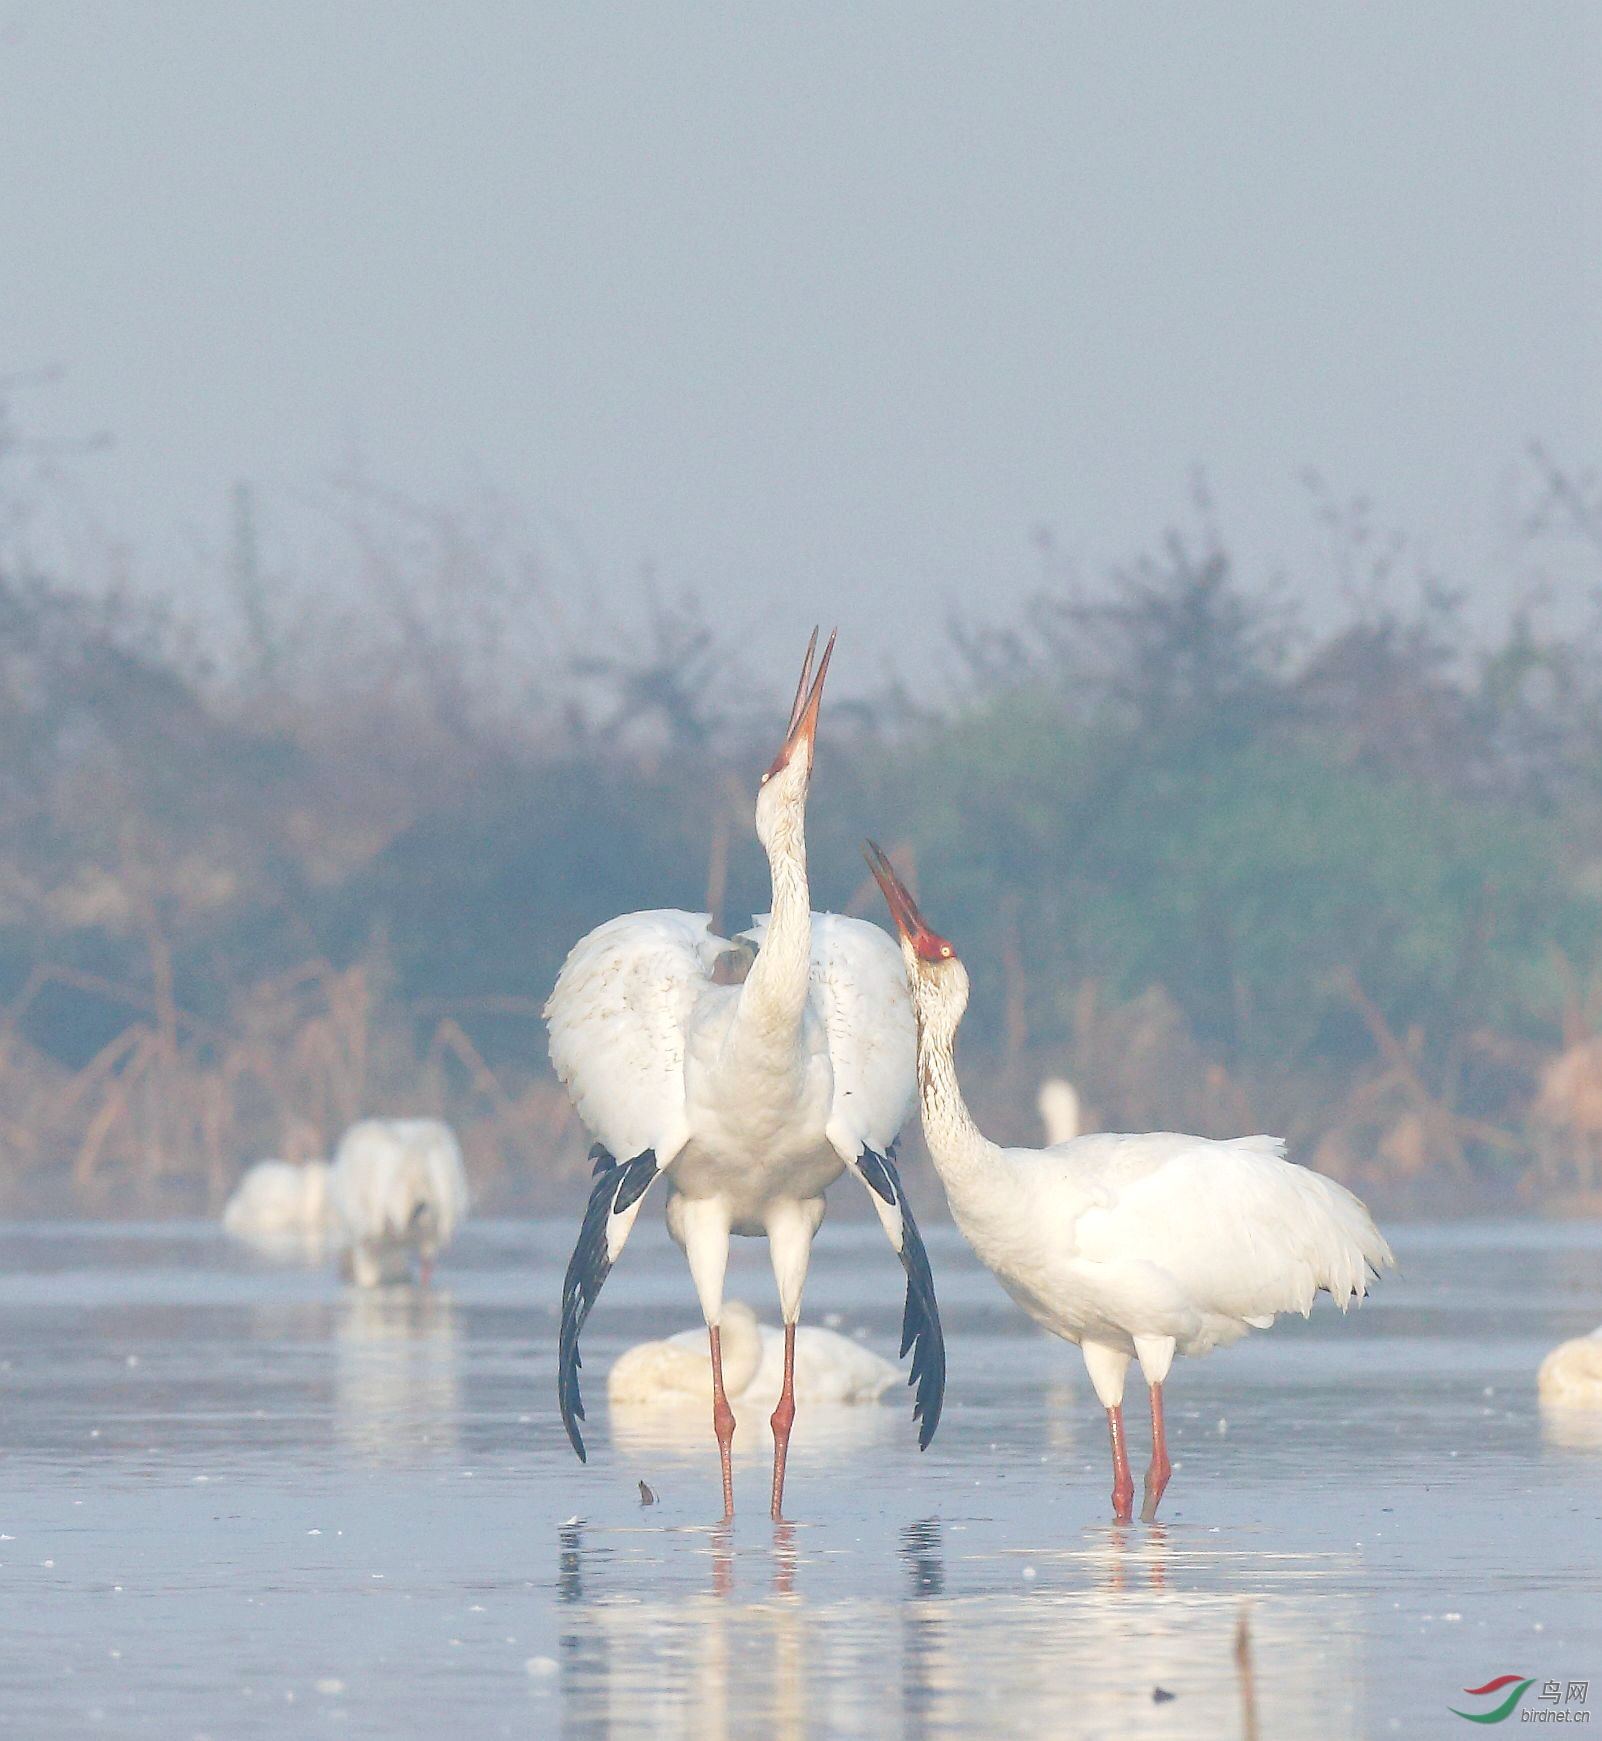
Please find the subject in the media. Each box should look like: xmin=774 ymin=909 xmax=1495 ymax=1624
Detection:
xmin=545 ymin=632 xmax=946 ymax=1518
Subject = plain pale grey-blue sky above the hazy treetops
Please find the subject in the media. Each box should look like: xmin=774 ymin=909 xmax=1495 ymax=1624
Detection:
xmin=0 ymin=0 xmax=1602 ymax=669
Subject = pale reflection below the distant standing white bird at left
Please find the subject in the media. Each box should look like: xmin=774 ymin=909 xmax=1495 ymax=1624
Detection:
xmin=334 ymin=1288 xmax=461 ymax=1466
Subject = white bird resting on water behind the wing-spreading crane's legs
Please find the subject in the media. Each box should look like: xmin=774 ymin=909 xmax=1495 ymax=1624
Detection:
xmin=606 ymin=1299 xmax=900 ymax=1407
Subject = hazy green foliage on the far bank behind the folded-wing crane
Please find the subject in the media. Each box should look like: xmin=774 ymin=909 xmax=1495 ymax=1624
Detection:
xmin=849 ymin=691 xmax=1602 ymax=1067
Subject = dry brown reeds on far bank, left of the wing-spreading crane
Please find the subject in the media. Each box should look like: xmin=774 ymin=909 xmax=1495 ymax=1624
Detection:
xmin=0 ymin=938 xmax=569 ymax=1213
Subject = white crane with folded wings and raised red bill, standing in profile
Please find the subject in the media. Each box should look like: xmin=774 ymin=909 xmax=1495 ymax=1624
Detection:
xmin=867 ymin=843 xmax=1395 ymax=1522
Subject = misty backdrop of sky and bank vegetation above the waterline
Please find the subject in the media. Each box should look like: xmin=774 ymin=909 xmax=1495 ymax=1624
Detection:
xmin=0 ymin=0 xmax=1602 ymax=1212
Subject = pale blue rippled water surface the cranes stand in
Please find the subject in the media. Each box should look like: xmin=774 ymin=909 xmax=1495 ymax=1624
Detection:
xmin=0 ymin=1222 xmax=1602 ymax=1741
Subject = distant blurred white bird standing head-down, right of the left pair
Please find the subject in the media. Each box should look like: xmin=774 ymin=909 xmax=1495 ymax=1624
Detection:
xmin=329 ymin=1118 xmax=467 ymax=1288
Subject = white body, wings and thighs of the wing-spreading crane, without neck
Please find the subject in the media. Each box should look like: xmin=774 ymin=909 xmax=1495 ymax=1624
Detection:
xmin=545 ymin=909 xmax=916 ymax=1295
